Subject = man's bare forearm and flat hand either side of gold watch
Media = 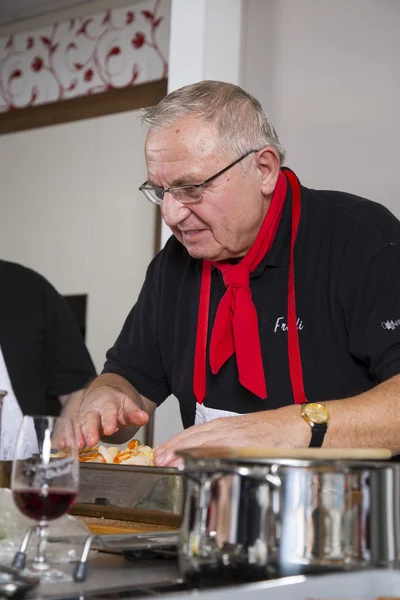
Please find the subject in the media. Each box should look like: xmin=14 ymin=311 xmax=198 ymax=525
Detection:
xmin=155 ymin=375 xmax=400 ymax=467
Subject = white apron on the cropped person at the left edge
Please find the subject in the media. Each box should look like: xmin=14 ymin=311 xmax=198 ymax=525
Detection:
xmin=0 ymin=346 xmax=37 ymax=460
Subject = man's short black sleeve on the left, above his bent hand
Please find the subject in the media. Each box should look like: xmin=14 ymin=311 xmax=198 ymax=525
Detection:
xmin=103 ymin=261 xmax=171 ymax=404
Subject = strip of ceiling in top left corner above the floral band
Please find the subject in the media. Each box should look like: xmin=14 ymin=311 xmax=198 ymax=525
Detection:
xmin=0 ymin=0 xmax=94 ymax=26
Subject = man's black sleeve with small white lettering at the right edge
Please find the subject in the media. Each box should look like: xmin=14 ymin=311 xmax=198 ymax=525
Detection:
xmin=344 ymin=245 xmax=400 ymax=382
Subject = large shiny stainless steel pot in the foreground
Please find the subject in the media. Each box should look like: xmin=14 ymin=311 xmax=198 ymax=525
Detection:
xmin=179 ymin=451 xmax=400 ymax=584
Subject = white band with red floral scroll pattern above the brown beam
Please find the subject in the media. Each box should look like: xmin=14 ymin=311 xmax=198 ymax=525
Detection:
xmin=0 ymin=0 xmax=170 ymax=112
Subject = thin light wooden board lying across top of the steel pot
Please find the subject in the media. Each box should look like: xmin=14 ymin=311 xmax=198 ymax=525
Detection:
xmin=177 ymin=447 xmax=392 ymax=460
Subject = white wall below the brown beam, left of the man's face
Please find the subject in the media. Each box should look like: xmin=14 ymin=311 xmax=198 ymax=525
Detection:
xmin=0 ymin=111 xmax=156 ymax=440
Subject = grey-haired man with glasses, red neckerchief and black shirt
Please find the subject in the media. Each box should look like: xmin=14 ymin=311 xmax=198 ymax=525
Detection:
xmin=76 ymin=81 xmax=400 ymax=465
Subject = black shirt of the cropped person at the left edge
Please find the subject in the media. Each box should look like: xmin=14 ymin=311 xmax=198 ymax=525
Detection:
xmin=0 ymin=260 xmax=96 ymax=414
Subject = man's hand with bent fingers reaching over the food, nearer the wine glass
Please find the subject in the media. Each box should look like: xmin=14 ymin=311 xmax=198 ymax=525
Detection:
xmin=77 ymin=374 xmax=155 ymax=448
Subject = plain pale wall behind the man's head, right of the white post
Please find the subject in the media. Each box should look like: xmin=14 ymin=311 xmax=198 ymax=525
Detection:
xmin=242 ymin=0 xmax=400 ymax=217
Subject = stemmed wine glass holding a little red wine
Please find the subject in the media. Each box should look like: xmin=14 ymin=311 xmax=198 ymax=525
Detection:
xmin=11 ymin=416 xmax=79 ymax=581
